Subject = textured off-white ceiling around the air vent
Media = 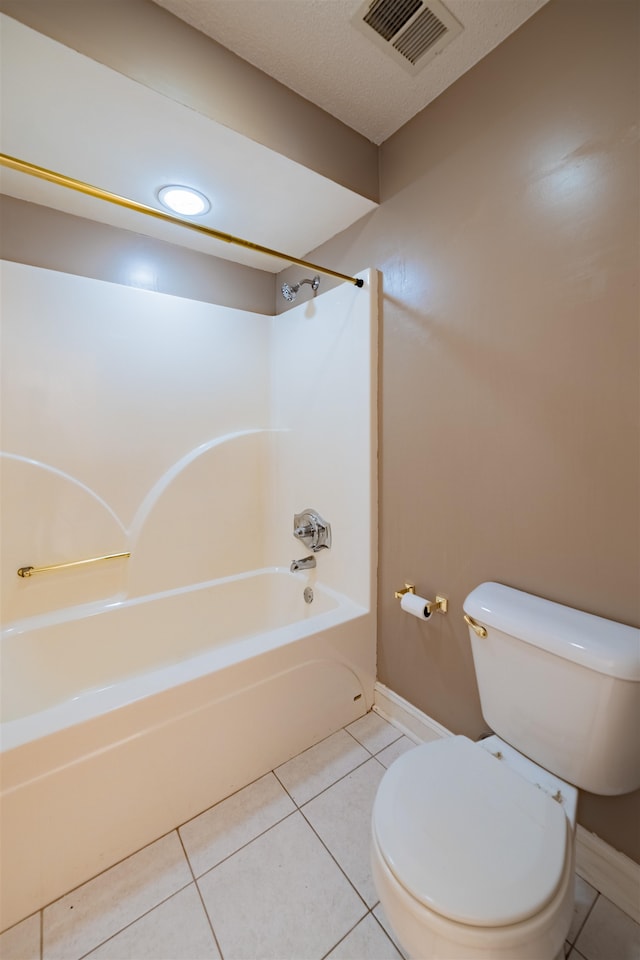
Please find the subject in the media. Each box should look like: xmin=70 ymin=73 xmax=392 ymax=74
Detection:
xmin=155 ymin=0 xmax=547 ymax=143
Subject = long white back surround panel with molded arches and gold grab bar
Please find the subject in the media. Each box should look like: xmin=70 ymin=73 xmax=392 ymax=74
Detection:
xmin=1 ymin=263 xmax=269 ymax=620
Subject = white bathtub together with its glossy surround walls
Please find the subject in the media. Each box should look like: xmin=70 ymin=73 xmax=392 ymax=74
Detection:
xmin=0 ymin=263 xmax=377 ymax=928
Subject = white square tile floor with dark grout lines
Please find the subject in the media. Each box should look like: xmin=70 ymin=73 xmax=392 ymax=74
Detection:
xmin=0 ymin=713 xmax=640 ymax=960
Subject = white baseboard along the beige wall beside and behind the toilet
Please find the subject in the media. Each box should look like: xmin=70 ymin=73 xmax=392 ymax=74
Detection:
xmin=373 ymin=683 xmax=640 ymax=923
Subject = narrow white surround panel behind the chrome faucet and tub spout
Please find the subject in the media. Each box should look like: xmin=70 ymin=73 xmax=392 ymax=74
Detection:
xmin=271 ymin=270 xmax=377 ymax=609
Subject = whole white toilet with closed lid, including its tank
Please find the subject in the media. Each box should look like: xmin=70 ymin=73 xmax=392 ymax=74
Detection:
xmin=371 ymin=583 xmax=640 ymax=960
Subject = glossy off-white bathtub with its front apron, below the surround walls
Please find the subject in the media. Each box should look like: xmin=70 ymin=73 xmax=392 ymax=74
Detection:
xmin=0 ymin=567 xmax=375 ymax=929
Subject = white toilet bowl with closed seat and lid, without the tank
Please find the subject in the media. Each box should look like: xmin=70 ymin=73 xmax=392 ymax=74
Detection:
xmin=372 ymin=737 xmax=576 ymax=960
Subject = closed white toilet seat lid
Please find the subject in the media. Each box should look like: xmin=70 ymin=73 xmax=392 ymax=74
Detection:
xmin=373 ymin=737 xmax=571 ymax=927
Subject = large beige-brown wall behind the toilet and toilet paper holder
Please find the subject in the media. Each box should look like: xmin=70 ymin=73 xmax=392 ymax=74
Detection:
xmin=278 ymin=0 xmax=640 ymax=860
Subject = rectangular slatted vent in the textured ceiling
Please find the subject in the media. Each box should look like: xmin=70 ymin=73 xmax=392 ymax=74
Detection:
xmin=352 ymin=0 xmax=463 ymax=74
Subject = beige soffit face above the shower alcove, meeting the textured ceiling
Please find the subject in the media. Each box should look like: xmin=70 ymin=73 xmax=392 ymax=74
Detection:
xmin=0 ymin=0 xmax=378 ymax=200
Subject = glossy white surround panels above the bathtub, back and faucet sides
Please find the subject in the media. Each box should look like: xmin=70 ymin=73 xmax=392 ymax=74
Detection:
xmin=0 ymin=262 xmax=375 ymax=622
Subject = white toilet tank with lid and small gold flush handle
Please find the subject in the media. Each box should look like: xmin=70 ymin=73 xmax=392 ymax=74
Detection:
xmin=464 ymin=583 xmax=640 ymax=796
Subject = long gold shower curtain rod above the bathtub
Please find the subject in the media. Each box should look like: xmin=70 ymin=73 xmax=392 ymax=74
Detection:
xmin=0 ymin=153 xmax=364 ymax=287
